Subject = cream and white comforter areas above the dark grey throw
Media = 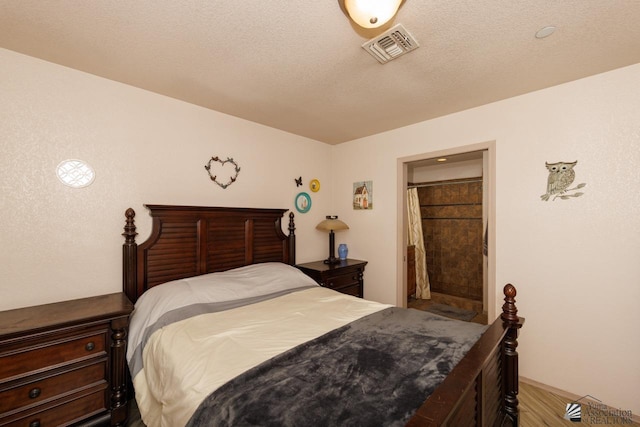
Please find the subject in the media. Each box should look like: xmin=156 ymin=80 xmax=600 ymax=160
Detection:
xmin=127 ymin=264 xmax=389 ymax=427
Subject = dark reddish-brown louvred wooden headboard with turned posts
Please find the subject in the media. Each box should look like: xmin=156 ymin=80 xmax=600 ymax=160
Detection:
xmin=122 ymin=205 xmax=296 ymax=303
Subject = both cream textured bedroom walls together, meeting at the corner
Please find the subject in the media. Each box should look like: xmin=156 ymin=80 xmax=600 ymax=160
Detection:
xmin=0 ymin=45 xmax=640 ymax=414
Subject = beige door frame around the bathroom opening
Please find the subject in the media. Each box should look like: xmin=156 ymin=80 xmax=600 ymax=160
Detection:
xmin=396 ymin=141 xmax=498 ymax=323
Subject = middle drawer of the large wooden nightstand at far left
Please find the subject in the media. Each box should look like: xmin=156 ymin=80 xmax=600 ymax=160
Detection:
xmin=0 ymin=360 xmax=107 ymax=414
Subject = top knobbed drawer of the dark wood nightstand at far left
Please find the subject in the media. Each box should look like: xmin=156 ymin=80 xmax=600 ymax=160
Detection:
xmin=0 ymin=331 xmax=107 ymax=382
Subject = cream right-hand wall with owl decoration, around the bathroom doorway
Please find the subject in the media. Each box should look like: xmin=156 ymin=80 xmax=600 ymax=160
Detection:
xmin=333 ymin=65 xmax=640 ymax=414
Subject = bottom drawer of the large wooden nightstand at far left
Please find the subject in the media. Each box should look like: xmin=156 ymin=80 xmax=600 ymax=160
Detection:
xmin=0 ymin=390 xmax=106 ymax=427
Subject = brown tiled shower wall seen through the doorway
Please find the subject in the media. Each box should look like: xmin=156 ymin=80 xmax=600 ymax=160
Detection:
xmin=418 ymin=178 xmax=483 ymax=301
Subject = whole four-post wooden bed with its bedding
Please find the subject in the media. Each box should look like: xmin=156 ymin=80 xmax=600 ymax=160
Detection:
xmin=123 ymin=205 xmax=523 ymax=426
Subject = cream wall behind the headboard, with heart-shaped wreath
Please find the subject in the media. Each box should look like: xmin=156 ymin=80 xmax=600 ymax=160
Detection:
xmin=0 ymin=49 xmax=331 ymax=310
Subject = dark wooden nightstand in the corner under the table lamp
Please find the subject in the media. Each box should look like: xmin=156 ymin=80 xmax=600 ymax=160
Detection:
xmin=296 ymin=259 xmax=367 ymax=298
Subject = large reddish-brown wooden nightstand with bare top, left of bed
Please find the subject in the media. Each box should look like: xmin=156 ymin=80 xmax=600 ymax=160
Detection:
xmin=0 ymin=293 xmax=133 ymax=427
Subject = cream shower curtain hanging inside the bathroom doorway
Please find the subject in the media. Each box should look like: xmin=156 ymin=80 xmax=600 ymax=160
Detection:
xmin=407 ymin=188 xmax=431 ymax=299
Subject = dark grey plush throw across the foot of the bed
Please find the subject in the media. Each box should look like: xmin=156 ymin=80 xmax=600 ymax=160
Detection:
xmin=188 ymin=307 xmax=487 ymax=427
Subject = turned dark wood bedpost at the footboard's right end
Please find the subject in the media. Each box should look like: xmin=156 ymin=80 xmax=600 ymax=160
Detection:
xmin=500 ymin=283 xmax=524 ymax=426
